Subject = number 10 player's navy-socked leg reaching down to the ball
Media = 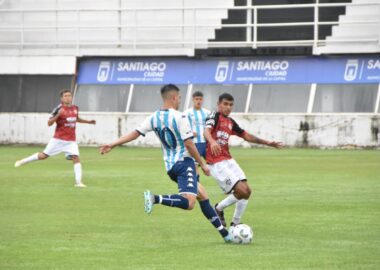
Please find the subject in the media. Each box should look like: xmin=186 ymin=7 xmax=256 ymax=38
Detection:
xmin=197 ymin=183 xmax=230 ymax=242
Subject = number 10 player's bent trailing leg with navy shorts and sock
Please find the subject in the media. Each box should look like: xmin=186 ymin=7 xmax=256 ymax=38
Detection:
xmin=144 ymin=158 xmax=198 ymax=214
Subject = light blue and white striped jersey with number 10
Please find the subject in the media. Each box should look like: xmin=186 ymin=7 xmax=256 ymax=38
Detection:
xmin=136 ymin=109 xmax=193 ymax=171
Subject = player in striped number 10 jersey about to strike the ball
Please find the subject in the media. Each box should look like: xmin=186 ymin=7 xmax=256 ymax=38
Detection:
xmin=100 ymin=84 xmax=231 ymax=242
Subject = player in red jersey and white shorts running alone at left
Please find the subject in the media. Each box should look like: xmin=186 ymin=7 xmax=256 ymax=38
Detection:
xmin=15 ymin=90 xmax=96 ymax=187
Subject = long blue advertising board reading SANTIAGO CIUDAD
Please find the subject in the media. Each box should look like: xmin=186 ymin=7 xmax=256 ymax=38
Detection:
xmin=77 ymin=55 xmax=380 ymax=84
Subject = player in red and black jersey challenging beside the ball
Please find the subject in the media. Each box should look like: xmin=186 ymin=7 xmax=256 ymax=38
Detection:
xmin=204 ymin=93 xmax=283 ymax=226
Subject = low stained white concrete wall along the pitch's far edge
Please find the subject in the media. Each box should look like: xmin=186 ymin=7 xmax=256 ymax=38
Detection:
xmin=0 ymin=113 xmax=380 ymax=148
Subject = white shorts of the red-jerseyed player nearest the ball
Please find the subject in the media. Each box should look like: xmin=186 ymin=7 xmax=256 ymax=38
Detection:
xmin=208 ymin=159 xmax=247 ymax=194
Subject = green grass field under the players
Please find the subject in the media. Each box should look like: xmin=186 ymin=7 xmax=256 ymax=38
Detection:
xmin=0 ymin=146 xmax=380 ymax=270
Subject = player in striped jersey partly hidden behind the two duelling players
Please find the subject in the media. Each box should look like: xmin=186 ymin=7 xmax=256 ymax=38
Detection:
xmin=185 ymin=91 xmax=210 ymax=180
